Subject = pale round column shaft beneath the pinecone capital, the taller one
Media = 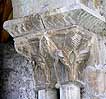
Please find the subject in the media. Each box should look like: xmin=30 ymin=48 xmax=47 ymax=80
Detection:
xmin=60 ymin=83 xmax=80 ymax=99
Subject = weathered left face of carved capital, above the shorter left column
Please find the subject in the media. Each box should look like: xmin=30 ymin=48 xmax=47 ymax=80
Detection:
xmin=15 ymin=38 xmax=51 ymax=88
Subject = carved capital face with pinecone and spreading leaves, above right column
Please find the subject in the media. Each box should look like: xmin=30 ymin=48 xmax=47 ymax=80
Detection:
xmin=48 ymin=29 xmax=92 ymax=80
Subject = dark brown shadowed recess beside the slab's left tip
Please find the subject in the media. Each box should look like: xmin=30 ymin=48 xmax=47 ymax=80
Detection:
xmin=0 ymin=0 xmax=13 ymax=43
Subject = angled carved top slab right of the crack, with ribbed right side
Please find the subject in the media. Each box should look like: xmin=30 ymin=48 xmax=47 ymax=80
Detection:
xmin=42 ymin=4 xmax=105 ymax=33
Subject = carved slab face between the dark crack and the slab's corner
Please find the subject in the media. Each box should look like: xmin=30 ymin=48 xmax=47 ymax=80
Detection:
xmin=42 ymin=9 xmax=76 ymax=29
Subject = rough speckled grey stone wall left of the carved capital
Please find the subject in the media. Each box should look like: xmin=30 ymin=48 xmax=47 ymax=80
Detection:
xmin=0 ymin=43 xmax=35 ymax=99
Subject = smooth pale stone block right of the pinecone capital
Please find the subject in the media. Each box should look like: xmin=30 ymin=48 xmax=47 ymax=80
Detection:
xmin=88 ymin=32 xmax=106 ymax=66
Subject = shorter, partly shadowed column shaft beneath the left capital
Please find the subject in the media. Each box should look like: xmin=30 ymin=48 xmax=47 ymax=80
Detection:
xmin=38 ymin=89 xmax=57 ymax=99
